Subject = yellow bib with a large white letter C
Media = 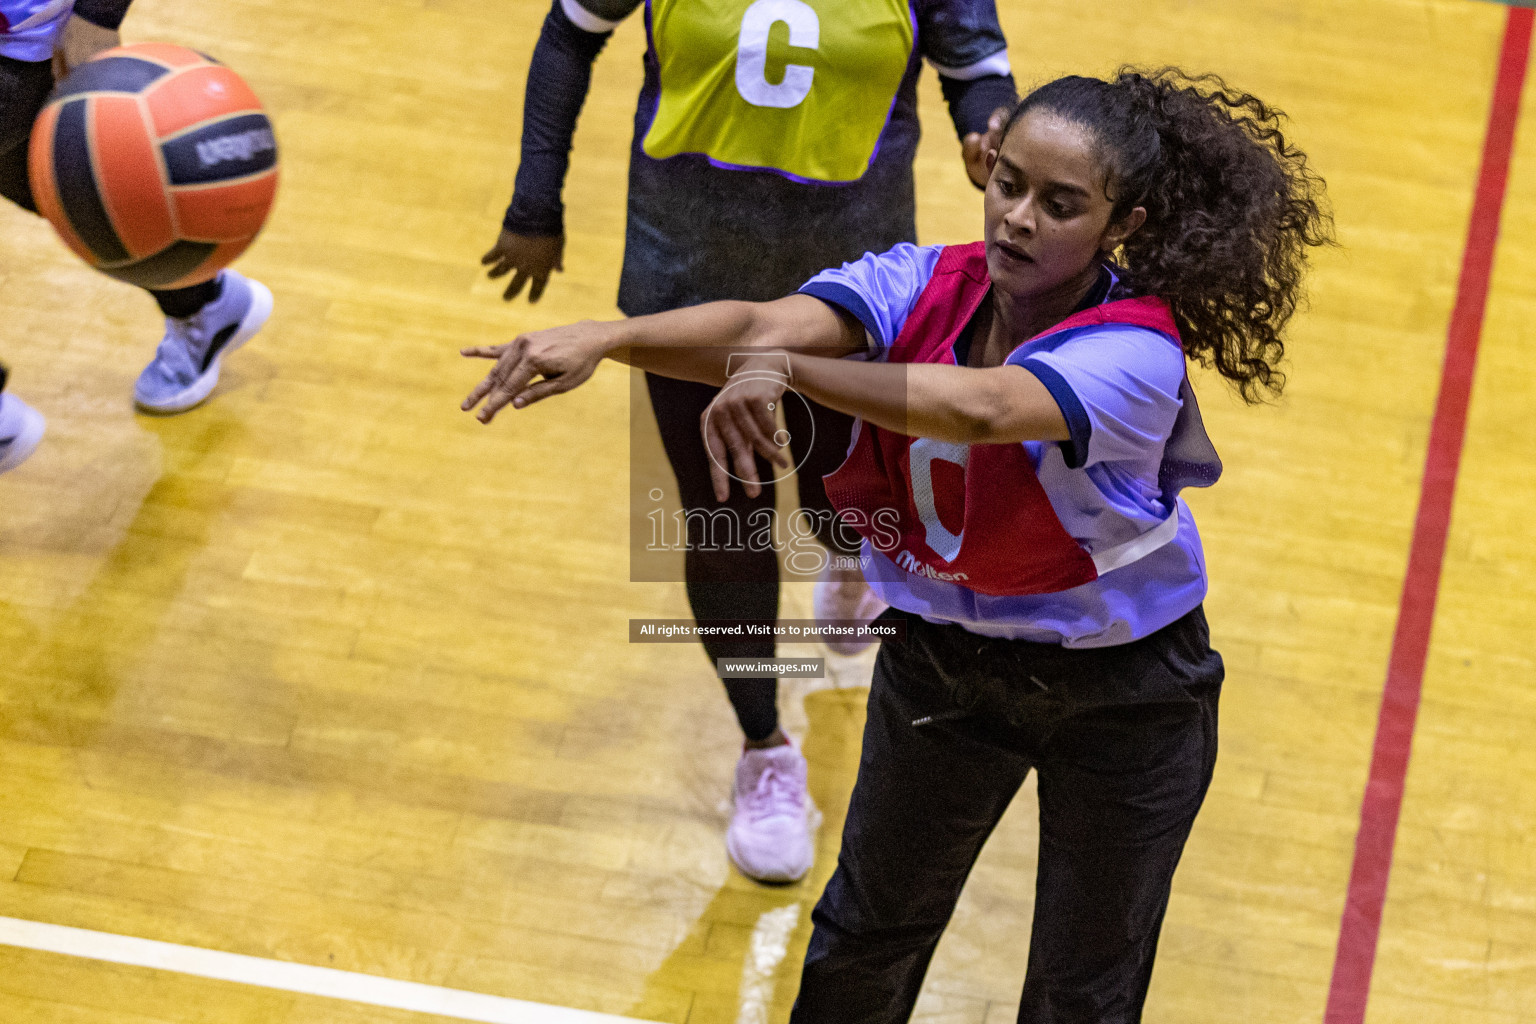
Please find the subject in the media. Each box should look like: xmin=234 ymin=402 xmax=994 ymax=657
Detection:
xmin=644 ymin=0 xmax=912 ymax=183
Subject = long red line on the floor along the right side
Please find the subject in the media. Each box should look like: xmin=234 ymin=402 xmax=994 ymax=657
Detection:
xmin=1322 ymin=8 xmax=1533 ymax=1024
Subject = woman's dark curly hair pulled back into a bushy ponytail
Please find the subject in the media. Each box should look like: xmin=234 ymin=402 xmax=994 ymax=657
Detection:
xmin=1012 ymin=68 xmax=1332 ymax=402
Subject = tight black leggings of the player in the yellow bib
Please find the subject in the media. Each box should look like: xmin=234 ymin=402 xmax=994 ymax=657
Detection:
xmin=645 ymin=373 xmax=859 ymax=740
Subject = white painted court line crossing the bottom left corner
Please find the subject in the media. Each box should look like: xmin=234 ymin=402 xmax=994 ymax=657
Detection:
xmin=0 ymin=917 xmax=644 ymax=1024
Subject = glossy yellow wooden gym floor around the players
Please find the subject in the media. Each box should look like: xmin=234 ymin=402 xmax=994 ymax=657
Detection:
xmin=0 ymin=0 xmax=1536 ymax=1024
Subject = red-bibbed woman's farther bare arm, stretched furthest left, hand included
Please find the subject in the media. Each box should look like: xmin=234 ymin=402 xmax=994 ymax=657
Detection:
xmin=462 ymin=295 xmax=865 ymax=424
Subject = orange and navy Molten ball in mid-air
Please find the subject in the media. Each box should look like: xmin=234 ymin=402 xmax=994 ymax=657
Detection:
xmin=28 ymin=43 xmax=278 ymax=289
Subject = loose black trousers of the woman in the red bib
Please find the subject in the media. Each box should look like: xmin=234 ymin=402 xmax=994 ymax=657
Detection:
xmin=790 ymin=608 xmax=1224 ymax=1024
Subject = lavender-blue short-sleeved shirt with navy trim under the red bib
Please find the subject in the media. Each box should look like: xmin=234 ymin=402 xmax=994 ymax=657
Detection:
xmin=800 ymin=244 xmax=1213 ymax=648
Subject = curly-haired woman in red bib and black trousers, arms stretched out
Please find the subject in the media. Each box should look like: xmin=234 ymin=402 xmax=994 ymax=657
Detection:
xmin=464 ymin=69 xmax=1330 ymax=1024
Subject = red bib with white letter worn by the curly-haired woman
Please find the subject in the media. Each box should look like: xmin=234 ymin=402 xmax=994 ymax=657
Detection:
xmin=823 ymin=243 xmax=1178 ymax=596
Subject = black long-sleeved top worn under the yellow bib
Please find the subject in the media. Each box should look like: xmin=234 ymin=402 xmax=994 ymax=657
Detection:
xmin=504 ymin=0 xmax=1017 ymax=316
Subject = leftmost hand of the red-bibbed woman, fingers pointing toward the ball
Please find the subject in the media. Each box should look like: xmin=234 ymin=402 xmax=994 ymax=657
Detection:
xmin=459 ymin=319 xmax=613 ymax=424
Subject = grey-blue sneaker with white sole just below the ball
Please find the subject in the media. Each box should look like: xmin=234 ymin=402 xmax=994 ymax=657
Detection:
xmin=134 ymin=270 xmax=272 ymax=413
